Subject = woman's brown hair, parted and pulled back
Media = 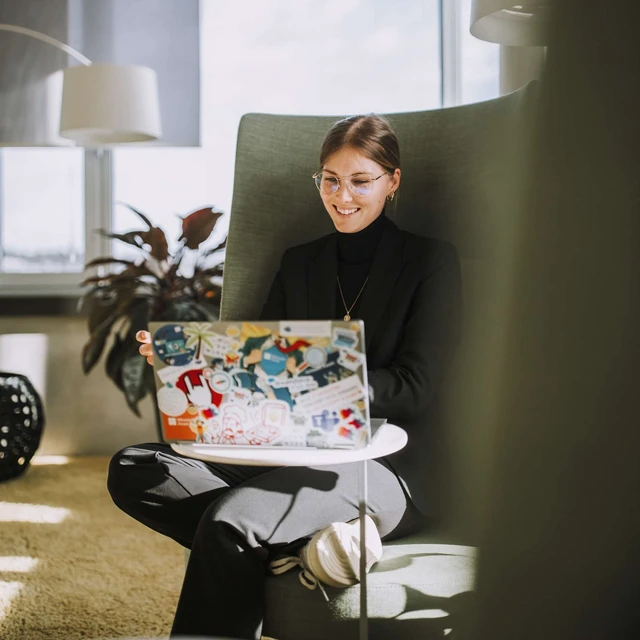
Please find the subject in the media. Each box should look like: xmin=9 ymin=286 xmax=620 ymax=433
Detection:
xmin=320 ymin=113 xmax=400 ymax=173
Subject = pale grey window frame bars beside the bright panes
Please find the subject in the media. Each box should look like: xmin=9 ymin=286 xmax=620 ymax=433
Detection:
xmin=0 ymin=0 xmax=490 ymax=299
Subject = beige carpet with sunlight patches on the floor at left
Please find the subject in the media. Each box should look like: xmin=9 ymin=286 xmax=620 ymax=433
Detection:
xmin=0 ymin=457 xmax=184 ymax=640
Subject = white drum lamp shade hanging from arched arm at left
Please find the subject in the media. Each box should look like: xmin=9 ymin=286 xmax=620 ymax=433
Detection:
xmin=60 ymin=64 xmax=162 ymax=146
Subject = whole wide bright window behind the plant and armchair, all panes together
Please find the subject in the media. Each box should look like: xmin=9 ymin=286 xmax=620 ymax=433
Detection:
xmin=0 ymin=0 xmax=499 ymax=295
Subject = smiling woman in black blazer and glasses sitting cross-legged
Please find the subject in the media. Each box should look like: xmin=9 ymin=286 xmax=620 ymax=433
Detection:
xmin=108 ymin=115 xmax=460 ymax=638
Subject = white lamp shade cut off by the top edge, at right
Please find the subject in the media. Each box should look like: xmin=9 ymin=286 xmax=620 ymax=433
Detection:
xmin=471 ymin=0 xmax=552 ymax=47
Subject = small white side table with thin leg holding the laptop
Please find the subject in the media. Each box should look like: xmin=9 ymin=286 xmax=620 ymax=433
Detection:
xmin=171 ymin=422 xmax=407 ymax=640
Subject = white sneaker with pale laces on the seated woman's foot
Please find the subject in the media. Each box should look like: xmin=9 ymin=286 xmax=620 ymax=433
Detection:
xmin=269 ymin=516 xmax=382 ymax=598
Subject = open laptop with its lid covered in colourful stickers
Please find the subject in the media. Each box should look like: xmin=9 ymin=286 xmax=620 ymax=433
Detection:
xmin=149 ymin=320 xmax=380 ymax=449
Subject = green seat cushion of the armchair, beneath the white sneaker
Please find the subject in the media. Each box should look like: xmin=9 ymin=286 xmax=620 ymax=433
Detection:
xmin=263 ymin=537 xmax=475 ymax=640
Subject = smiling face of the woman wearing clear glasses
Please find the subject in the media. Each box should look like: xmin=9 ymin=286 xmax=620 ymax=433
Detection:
xmin=320 ymin=147 xmax=400 ymax=233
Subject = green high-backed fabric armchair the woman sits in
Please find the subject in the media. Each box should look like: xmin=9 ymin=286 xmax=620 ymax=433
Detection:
xmin=189 ymin=84 xmax=536 ymax=640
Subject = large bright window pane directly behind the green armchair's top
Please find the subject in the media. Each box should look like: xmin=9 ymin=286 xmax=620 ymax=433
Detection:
xmin=113 ymin=0 xmax=441 ymax=242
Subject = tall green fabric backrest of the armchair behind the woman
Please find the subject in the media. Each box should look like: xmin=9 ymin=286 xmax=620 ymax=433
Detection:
xmin=221 ymin=83 xmax=538 ymax=539
